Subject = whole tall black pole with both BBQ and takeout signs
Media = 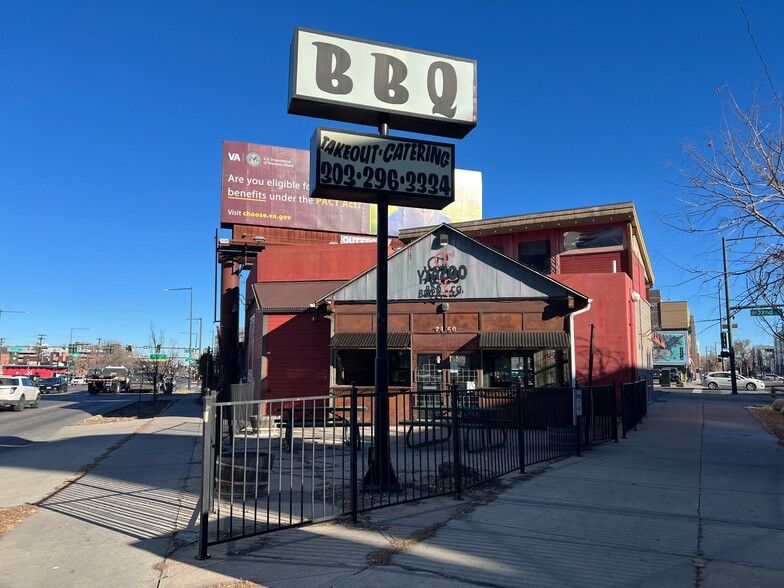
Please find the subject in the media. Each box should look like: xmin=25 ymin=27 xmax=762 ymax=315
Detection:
xmin=288 ymin=28 xmax=476 ymax=491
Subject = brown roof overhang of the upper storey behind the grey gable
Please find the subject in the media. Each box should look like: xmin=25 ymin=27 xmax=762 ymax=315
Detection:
xmin=398 ymin=202 xmax=654 ymax=283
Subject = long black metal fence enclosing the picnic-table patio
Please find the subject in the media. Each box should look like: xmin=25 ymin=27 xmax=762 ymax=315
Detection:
xmin=200 ymin=386 xmax=618 ymax=557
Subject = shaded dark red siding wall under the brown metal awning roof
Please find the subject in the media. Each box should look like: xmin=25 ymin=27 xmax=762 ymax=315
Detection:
xmin=264 ymin=314 xmax=329 ymax=398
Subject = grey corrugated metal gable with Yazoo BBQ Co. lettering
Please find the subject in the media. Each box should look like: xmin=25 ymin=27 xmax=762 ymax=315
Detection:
xmin=321 ymin=224 xmax=588 ymax=309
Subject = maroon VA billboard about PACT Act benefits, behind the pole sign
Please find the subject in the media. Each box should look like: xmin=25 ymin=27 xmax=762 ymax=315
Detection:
xmin=220 ymin=141 xmax=482 ymax=236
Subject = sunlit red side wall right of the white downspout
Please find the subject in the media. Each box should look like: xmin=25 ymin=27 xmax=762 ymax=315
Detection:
xmin=553 ymin=272 xmax=635 ymax=385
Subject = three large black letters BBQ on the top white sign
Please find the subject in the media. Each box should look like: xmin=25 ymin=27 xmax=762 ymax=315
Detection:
xmin=313 ymin=41 xmax=457 ymax=118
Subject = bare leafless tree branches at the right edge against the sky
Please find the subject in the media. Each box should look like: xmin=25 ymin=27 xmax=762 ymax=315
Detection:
xmin=663 ymin=87 xmax=784 ymax=336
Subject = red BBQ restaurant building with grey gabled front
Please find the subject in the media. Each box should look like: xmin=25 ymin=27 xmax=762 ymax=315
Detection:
xmin=245 ymin=203 xmax=653 ymax=398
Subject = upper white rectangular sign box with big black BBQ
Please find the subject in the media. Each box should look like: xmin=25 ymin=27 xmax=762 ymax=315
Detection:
xmin=288 ymin=27 xmax=476 ymax=139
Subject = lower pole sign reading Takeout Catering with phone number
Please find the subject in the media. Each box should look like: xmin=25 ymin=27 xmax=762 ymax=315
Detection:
xmin=310 ymin=127 xmax=455 ymax=210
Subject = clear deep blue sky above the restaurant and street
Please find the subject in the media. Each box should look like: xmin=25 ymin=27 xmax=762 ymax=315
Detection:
xmin=0 ymin=0 xmax=784 ymax=350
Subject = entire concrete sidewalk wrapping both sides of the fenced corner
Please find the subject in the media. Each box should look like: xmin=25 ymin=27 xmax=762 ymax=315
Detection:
xmin=0 ymin=393 xmax=784 ymax=588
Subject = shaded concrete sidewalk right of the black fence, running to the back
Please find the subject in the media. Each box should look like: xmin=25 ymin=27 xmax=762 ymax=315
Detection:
xmin=161 ymin=394 xmax=784 ymax=588
